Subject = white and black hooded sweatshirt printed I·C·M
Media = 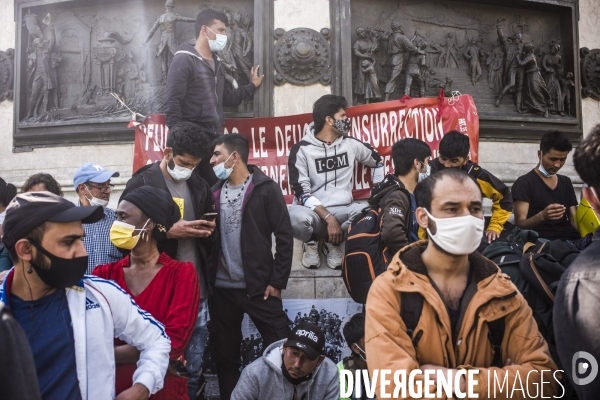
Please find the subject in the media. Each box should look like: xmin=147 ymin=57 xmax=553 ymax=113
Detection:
xmin=288 ymin=122 xmax=383 ymax=209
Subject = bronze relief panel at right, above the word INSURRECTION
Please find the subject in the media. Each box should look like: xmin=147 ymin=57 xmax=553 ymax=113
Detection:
xmin=351 ymin=0 xmax=576 ymax=120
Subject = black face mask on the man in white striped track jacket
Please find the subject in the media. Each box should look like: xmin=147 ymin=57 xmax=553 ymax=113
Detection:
xmin=29 ymin=239 xmax=88 ymax=288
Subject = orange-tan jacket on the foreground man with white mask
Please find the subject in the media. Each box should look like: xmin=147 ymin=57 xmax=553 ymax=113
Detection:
xmin=365 ymin=241 xmax=561 ymax=399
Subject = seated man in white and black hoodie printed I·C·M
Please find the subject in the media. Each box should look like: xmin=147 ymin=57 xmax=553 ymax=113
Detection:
xmin=288 ymin=94 xmax=383 ymax=269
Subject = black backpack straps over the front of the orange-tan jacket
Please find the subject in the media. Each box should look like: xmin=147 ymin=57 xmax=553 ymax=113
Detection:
xmin=400 ymin=292 xmax=505 ymax=368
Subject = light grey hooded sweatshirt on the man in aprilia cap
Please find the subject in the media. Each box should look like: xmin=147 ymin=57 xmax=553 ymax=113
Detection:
xmin=231 ymin=339 xmax=340 ymax=400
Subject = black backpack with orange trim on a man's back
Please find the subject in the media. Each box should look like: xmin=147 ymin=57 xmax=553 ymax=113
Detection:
xmin=342 ymin=188 xmax=410 ymax=304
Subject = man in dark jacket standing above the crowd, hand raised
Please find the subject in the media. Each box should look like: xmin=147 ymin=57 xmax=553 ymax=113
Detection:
xmin=165 ymin=10 xmax=264 ymax=186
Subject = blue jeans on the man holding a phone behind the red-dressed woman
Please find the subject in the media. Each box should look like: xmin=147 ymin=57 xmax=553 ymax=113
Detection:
xmin=185 ymin=298 xmax=208 ymax=400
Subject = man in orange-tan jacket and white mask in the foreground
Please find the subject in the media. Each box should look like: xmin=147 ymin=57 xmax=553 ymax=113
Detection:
xmin=365 ymin=169 xmax=561 ymax=399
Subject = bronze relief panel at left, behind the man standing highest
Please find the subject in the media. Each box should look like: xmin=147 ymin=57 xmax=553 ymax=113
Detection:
xmin=16 ymin=0 xmax=254 ymax=128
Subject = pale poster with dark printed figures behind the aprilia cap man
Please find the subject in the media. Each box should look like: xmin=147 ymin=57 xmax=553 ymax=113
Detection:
xmin=202 ymin=299 xmax=362 ymax=398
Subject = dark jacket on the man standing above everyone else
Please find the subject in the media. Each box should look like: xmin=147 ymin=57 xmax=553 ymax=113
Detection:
xmin=164 ymin=43 xmax=255 ymax=134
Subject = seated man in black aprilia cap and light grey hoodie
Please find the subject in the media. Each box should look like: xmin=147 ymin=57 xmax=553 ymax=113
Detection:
xmin=231 ymin=322 xmax=340 ymax=400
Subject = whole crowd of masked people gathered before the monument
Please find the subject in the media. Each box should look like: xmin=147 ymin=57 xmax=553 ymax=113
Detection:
xmin=0 ymin=10 xmax=600 ymax=400
